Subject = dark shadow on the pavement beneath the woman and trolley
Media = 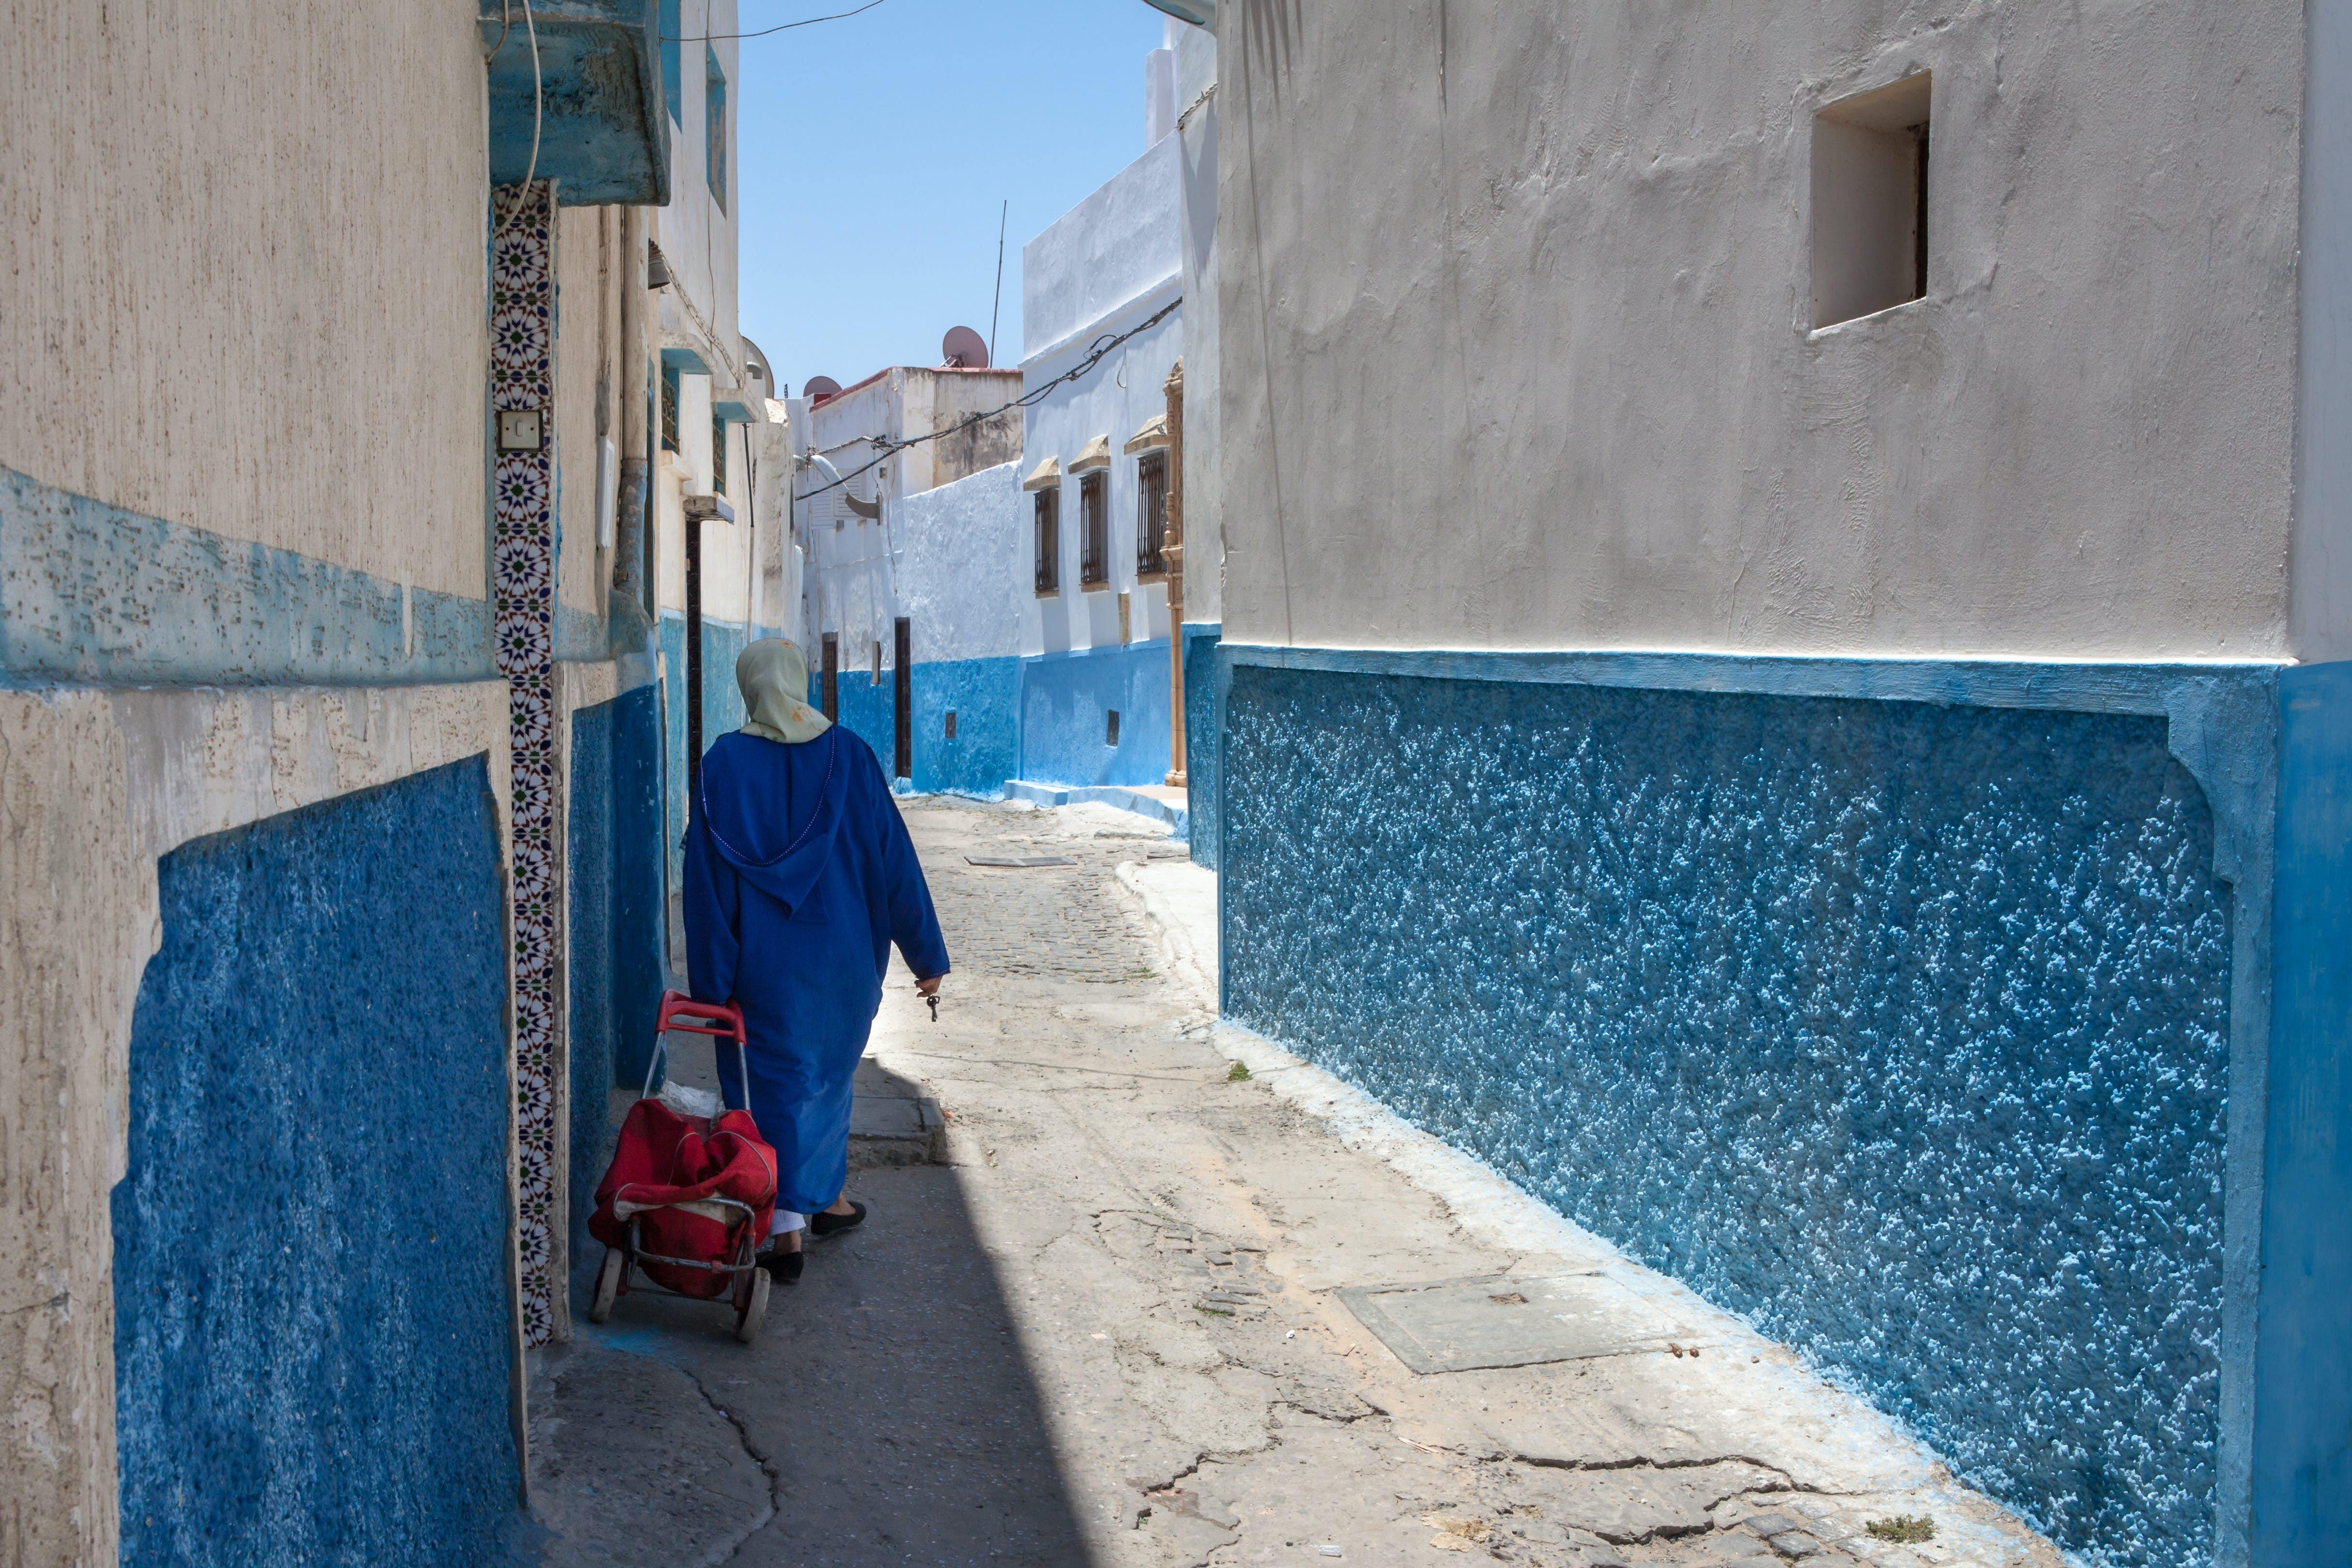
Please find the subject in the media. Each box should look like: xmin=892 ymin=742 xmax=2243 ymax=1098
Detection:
xmin=532 ymin=1051 xmax=1091 ymax=1568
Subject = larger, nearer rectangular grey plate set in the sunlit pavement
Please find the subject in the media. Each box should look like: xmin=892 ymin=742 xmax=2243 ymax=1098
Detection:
xmin=1338 ymin=1274 xmax=1693 ymax=1373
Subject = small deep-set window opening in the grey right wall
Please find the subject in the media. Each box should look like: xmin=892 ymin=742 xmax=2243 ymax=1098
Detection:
xmin=1814 ymin=71 xmax=1933 ymax=329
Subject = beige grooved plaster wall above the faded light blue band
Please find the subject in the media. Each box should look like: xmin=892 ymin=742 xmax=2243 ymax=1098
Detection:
xmin=0 ymin=0 xmax=489 ymax=597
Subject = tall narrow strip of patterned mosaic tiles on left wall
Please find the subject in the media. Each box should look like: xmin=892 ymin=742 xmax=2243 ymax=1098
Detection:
xmin=489 ymin=181 xmax=562 ymax=1345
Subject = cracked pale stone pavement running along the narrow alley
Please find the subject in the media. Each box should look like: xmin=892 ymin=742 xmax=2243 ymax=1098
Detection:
xmin=532 ymin=799 xmax=2058 ymax=1568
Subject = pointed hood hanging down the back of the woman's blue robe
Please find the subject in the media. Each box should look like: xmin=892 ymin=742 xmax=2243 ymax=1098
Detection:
xmin=699 ymin=728 xmax=849 ymax=914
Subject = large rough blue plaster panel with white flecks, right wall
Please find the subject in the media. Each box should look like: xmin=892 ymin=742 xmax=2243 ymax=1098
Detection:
xmin=1221 ymin=661 xmax=2232 ymax=1566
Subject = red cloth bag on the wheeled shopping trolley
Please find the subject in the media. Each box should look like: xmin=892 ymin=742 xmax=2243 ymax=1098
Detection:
xmin=588 ymin=1100 xmax=776 ymax=1298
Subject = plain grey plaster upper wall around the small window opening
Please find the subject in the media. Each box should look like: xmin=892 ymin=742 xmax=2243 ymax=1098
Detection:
xmin=1216 ymin=0 xmax=2305 ymax=658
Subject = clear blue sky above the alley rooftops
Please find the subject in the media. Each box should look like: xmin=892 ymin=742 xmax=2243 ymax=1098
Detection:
xmin=736 ymin=0 xmax=1162 ymax=393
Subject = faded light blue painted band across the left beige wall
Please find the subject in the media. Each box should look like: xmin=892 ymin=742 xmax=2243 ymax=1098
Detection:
xmin=0 ymin=468 xmax=496 ymax=687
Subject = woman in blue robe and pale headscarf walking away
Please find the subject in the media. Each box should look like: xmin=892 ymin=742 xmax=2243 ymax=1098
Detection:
xmin=687 ymin=639 xmax=948 ymax=1284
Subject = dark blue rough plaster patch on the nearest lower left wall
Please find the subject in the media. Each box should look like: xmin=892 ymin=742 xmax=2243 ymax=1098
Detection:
xmin=113 ymin=757 xmax=522 ymax=1568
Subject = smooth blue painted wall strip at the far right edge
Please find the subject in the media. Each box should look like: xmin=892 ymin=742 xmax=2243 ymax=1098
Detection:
xmin=2251 ymin=663 xmax=2352 ymax=1568
